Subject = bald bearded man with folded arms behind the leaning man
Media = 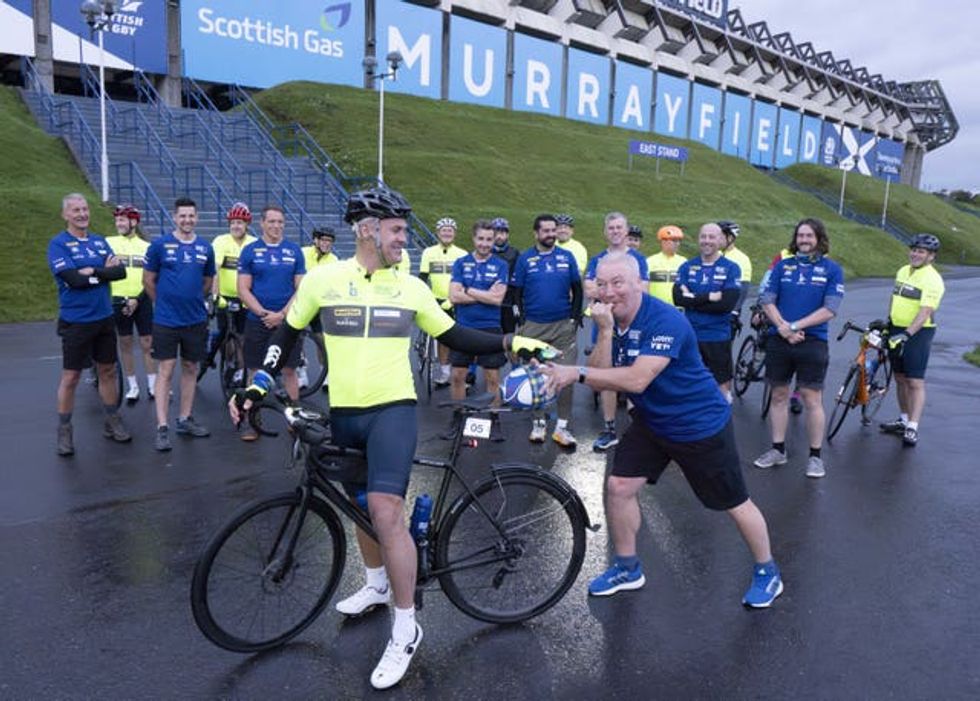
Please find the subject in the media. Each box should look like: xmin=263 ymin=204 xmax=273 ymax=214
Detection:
xmin=674 ymin=223 xmax=742 ymax=404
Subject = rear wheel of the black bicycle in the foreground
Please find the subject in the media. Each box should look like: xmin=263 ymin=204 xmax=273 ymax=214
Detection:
xmin=435 ymin=472 xmax=585 ymax=623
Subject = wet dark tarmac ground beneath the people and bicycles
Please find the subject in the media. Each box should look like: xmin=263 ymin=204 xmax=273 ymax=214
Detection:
xmin=0 ymin=276 xmax=980 ymax=699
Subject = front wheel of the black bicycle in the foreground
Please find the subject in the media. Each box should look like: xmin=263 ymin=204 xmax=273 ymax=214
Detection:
xmin=191 ymin=492 xmax=347 ymax=652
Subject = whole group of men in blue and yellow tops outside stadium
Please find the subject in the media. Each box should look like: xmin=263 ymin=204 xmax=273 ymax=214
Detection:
xmin=48 ymin=185 xmax=943 ymax=688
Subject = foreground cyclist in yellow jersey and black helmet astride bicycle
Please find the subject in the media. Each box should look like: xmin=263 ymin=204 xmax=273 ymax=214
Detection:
xmin=229 ymin=186 xmax=555 ymax=689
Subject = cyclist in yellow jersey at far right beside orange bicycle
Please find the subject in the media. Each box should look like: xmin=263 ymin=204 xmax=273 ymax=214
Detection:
xmin=881 ymin=234 xmax=946 ymax=447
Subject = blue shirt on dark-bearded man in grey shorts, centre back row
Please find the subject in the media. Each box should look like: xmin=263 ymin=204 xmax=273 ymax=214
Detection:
xmin=511 ymin=246 xmax=582 ymax=324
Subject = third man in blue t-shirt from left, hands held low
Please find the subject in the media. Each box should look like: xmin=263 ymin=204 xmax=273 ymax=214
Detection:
xmin=238 ymin=205 xmax=306 ymax=441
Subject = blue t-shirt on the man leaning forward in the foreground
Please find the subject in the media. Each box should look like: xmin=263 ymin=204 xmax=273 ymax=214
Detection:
xmin=612 ymin=293 xmax=731 ymax=443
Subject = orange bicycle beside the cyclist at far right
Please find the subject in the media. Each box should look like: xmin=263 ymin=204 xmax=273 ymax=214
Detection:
xmin=827 ymin=319 xmax=892 ymax=441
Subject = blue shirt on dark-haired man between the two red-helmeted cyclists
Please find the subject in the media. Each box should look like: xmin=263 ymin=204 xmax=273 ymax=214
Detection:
xmin=143 ymin=233 xmax=215 ymax=328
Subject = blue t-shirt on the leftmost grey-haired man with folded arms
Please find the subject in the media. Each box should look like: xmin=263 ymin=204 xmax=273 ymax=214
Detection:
xmin=48 ymin=231 xmax=112 ymax=323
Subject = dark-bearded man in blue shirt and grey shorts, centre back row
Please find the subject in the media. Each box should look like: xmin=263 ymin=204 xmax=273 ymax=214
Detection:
xmin=511 ymin=214 xmax=582 ymax=449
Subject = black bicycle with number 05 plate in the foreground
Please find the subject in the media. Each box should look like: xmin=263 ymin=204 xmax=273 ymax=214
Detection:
xmin=191 ymin=392 xmax=598 ymax=652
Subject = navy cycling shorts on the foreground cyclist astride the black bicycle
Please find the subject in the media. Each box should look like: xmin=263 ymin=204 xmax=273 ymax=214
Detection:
xmin=330 ymin=403 xmax=418 ymax=498
